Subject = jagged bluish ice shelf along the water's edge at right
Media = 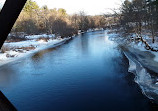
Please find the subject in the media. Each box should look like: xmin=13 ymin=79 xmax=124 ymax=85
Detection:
xmin=124 ymin=52 xmax=158 ymax=102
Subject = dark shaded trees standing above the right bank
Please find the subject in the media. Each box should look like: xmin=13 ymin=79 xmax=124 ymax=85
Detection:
xmin=118 ymin=0 xmax=158 ymax=43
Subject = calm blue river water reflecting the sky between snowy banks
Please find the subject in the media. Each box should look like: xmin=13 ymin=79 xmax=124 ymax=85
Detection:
xmin=0 ymin=31 xmax=157 ymax=111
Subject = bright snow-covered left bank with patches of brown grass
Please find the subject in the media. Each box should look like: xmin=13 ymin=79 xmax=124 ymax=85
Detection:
xmin=0 ymin=35 xmax=71 ymax=66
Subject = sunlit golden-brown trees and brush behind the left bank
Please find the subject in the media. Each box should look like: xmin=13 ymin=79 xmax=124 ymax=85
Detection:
xmin=12 ymin=0 xmax=105 ymax=37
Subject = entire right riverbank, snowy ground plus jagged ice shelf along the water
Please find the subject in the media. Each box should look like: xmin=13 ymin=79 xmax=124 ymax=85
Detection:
xmin=108 ymin=29 xmax=158 ymax=103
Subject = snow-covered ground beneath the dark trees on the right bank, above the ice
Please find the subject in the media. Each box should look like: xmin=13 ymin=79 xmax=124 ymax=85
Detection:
xmin=108 ymin=30 xmax=158 ymax=62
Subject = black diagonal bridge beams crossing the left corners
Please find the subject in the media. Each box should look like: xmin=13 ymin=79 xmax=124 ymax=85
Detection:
xmin=0 ymin=0 xmax=27 ymax=111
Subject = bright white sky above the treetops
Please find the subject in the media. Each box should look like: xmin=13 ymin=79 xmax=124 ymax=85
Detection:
xmin=0 ymin=0 xmax=122 ymax=15
